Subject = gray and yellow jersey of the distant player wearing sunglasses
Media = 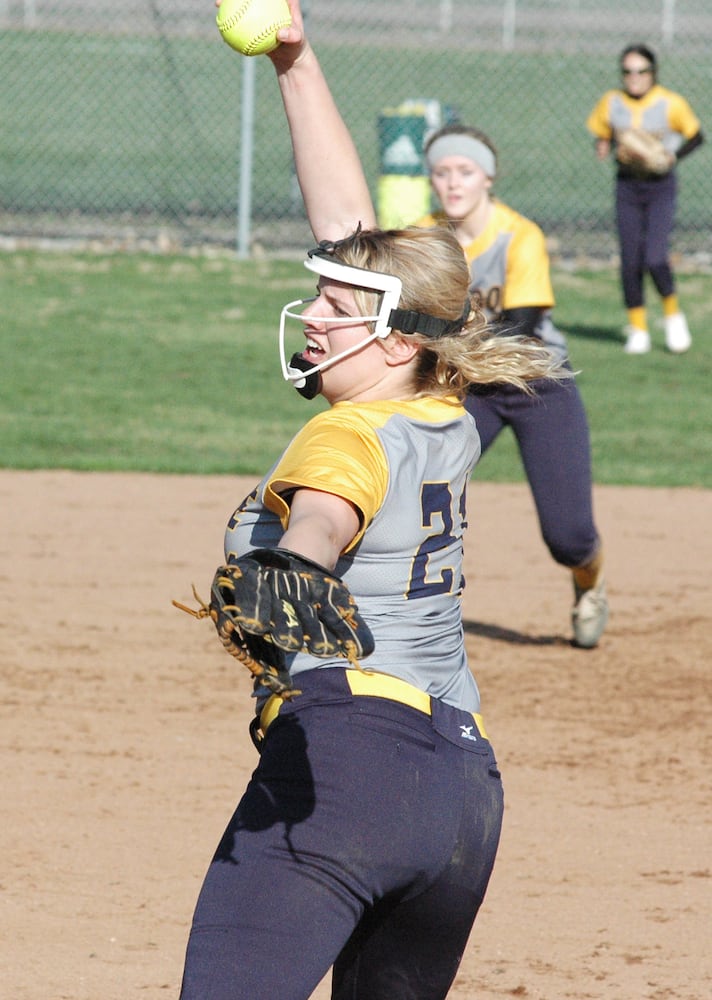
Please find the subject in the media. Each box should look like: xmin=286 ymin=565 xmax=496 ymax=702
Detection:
xmin=586 ymin=84 xmax=700 ymax=153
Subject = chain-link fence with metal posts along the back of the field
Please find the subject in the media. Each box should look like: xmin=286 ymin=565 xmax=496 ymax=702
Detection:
xmin=0 ymin=0 xmax=712 ymax=259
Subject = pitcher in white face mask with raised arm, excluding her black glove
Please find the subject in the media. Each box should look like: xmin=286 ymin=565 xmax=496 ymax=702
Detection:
xmin=182 ymin=2 xmax=568 ymax=1000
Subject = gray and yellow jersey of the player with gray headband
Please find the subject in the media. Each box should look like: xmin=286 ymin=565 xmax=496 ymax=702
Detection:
xmin=417 ymin=199 xmax=567 ymax=358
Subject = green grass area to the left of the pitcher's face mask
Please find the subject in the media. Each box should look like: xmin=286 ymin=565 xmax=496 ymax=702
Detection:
xmin=0 ymin=254 xmax=326 ymax=472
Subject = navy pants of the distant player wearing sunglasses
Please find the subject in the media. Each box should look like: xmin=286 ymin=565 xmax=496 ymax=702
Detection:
xmin=616 ymin=173 xmax=677 ymax=309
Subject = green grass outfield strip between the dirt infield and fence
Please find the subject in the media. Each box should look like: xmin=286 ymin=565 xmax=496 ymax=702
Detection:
xmin=0 ymin=251 xmax=712 ymax=488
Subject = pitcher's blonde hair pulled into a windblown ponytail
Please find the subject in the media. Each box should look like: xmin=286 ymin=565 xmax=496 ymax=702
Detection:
xmin=332 ymin=226 xmax=570 ymax=400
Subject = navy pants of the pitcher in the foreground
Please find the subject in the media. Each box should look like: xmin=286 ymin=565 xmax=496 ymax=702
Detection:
xmin=181 ymin=668 xmax=503 ymax=1000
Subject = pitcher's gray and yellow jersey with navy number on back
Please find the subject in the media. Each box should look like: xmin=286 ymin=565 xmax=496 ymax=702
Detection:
xmin=225 ymin=398 xmax=480 ymax=712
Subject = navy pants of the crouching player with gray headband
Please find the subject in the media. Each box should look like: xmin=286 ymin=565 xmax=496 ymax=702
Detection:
xmin=465 ymin=379 xmax=599 ymax=567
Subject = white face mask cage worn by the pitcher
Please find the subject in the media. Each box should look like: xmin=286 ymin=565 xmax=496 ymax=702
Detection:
xmin=279 ymin=254 xmax=403 ymax=388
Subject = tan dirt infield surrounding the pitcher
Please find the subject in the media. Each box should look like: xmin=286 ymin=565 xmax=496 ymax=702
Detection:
xmin=0 ymin=472 xmax=712 ymax=1000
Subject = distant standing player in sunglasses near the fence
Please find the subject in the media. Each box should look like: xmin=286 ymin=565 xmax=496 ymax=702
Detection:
xmin=586 ymin=45 xmax=703 ymax=354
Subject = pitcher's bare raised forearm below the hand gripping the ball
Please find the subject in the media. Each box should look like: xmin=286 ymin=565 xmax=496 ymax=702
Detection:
xmin=278 ymin=47 xmax=376 ymax=240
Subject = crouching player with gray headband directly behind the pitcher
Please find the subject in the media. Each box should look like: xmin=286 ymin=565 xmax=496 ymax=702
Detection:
xmin=419 ymin=124 xmax=608 ymax=648
